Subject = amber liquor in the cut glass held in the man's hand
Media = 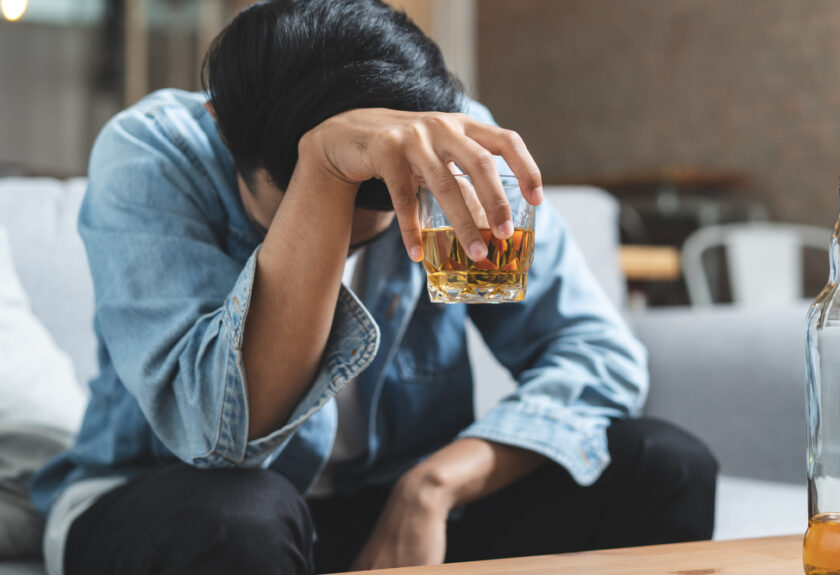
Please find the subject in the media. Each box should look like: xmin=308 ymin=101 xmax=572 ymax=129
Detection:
xmin=422 ymin=227 xmax=534 ymax=303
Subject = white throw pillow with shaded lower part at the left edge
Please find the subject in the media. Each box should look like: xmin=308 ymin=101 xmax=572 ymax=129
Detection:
xmin=0 ymin=227 xmax=87 ymax=559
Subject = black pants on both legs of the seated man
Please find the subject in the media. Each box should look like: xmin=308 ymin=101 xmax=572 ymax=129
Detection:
xmin=65 ymin=419 xmax=717 ymax=575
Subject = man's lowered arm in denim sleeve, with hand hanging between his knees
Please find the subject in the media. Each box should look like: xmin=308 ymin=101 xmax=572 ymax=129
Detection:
xmin=356 ymin=102 xmax=647 ymax=569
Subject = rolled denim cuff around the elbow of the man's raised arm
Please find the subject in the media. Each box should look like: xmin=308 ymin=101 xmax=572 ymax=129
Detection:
xmin=193 ymin=248 xmax=380 ymax=467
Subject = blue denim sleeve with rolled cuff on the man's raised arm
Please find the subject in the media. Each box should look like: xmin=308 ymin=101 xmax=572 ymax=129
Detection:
xmin=79 ymin=107 xmax=378 ymax=467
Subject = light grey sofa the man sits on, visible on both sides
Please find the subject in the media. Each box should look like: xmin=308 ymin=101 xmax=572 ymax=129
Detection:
xmin=0 ymin=179 xmax=807 ymax=574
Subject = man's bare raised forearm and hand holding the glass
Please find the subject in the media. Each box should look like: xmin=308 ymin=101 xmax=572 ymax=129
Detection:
xmin=243 ymin=109 xmax=542 ymax=439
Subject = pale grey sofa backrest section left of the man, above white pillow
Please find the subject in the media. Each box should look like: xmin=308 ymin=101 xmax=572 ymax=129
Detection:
xmin=0 ymin=178 xmax=97 ymax=383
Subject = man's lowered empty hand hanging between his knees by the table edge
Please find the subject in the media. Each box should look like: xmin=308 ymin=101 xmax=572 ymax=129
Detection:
xmin=352 ymin=474 xmax=450 ymax=571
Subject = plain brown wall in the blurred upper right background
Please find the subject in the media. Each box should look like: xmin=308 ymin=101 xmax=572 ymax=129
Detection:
xmin=477 ymin=0 xmax=840 ymax=225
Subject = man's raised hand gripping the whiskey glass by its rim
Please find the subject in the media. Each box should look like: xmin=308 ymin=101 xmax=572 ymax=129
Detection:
xmin=298 ymin=108 xmax=542 ymax=261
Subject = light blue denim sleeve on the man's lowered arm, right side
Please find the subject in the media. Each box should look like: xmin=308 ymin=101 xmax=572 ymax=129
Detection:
xmin=461 ymin=103 xmax=648 ymax=485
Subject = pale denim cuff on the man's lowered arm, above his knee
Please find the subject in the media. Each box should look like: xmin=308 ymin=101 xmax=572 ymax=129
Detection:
xmin=458 ymin=400 xmax=610 ymax=486
